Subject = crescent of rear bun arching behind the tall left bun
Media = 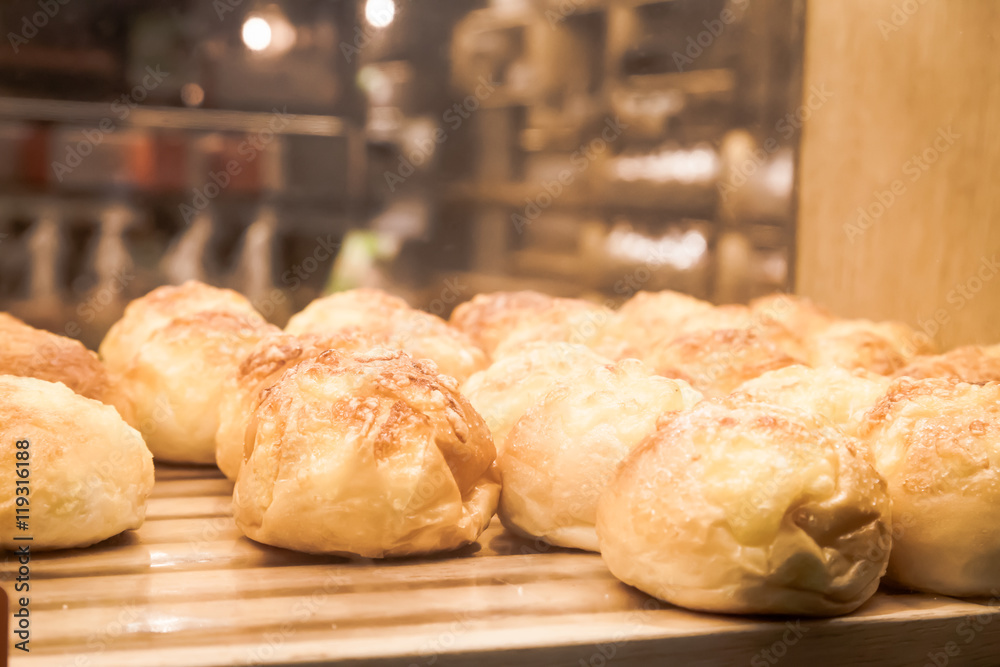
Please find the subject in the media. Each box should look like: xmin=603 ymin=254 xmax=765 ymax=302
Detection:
xmin=98 ymin=280 xmax=264 ymax=375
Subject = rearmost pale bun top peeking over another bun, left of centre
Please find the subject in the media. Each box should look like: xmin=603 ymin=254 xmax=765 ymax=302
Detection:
xmin=285 ymin=288 xmax=413 ymax=336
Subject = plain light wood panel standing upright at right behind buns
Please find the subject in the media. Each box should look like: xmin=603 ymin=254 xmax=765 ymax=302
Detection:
xmin=796 ymin=0 xmax=1000 ymax=348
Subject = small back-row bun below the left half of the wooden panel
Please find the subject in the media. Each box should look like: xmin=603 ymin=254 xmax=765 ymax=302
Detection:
xmin=806 ymin=320 xmax=933 ymax=375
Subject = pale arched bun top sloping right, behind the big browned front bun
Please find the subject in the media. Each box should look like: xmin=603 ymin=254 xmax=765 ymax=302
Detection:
xmin=285 ymin=289 xmax=488 ymax=382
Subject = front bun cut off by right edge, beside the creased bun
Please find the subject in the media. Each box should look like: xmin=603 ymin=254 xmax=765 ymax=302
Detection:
xmin=861 ymin=378 xmax=1000 ymax=596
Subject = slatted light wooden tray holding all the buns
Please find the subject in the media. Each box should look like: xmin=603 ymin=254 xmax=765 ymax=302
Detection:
xmin=0 ymin=466 xmax=1000 ymax=667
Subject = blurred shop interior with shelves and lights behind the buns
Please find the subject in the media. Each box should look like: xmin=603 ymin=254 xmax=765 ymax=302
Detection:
xmin=0 ymin=0 xmax=800 ymax=346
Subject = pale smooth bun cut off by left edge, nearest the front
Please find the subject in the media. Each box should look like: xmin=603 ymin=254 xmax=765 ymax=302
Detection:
xmin=0 ymin=375 xmax=153 ymax=551
